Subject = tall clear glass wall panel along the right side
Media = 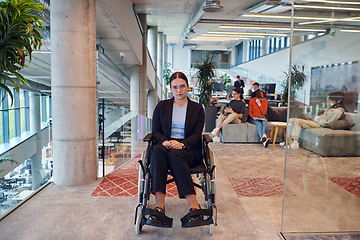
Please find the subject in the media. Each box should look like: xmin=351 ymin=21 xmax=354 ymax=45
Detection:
xmin=281 ymin=1 xmax=360 ymax=239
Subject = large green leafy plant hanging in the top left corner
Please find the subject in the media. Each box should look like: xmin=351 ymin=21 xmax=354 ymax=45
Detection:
xmin=0 ymin=0 xmax=46 ymax=101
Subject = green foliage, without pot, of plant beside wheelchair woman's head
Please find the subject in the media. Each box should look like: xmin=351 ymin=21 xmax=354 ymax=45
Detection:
xmin=195 ymin=54 xmax=216 ymax=107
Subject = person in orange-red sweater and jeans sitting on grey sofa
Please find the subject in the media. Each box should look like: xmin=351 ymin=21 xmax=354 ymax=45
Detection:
xmin=249 ymin=89 xmax=270 ymax=147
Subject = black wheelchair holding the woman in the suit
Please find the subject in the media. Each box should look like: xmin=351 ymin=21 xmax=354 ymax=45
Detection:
xmin=134 ymin=134 xmax=217 ymax=235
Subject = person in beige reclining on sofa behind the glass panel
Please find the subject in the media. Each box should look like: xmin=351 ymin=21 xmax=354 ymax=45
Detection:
xmin=286 ymin=92 xmax=345 ymax=149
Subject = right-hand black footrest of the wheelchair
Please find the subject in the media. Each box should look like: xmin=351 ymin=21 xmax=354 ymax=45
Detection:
xmin=180 ymin=209 xmax=214 ymax=228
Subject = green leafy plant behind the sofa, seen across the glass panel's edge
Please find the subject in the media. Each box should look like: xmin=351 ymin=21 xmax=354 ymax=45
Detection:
xmin=281 ymin=62 xmax=307 ymax=103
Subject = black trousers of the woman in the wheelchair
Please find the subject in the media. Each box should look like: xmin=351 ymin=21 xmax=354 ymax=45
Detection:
xmin=150 ymin=144 xmax=199 ymax=198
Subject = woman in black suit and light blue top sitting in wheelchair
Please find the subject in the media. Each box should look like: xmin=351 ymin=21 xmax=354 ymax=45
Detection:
xmin=148 ymin=72 xmax=205 ymax=226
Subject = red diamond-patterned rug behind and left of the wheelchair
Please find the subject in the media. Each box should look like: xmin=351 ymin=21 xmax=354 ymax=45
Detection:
xmin=91 ymin=154 xmax=178 ymax=197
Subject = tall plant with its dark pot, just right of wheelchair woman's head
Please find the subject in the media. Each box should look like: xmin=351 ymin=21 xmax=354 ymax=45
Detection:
xmin=195 ymin=54 xmax=217 ymax=132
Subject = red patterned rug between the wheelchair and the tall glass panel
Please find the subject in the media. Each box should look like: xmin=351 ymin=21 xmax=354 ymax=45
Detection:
xmin=229 ymin=178 xmax=295 ymax=197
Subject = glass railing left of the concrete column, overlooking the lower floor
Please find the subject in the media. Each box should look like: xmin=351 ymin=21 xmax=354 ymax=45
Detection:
xmin=0 ymin=90 xmax=53 ymax=219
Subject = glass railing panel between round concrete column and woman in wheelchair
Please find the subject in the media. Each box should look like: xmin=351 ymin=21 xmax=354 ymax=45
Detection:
xmin=98 ymin=102 xmax=152 ymax=177
